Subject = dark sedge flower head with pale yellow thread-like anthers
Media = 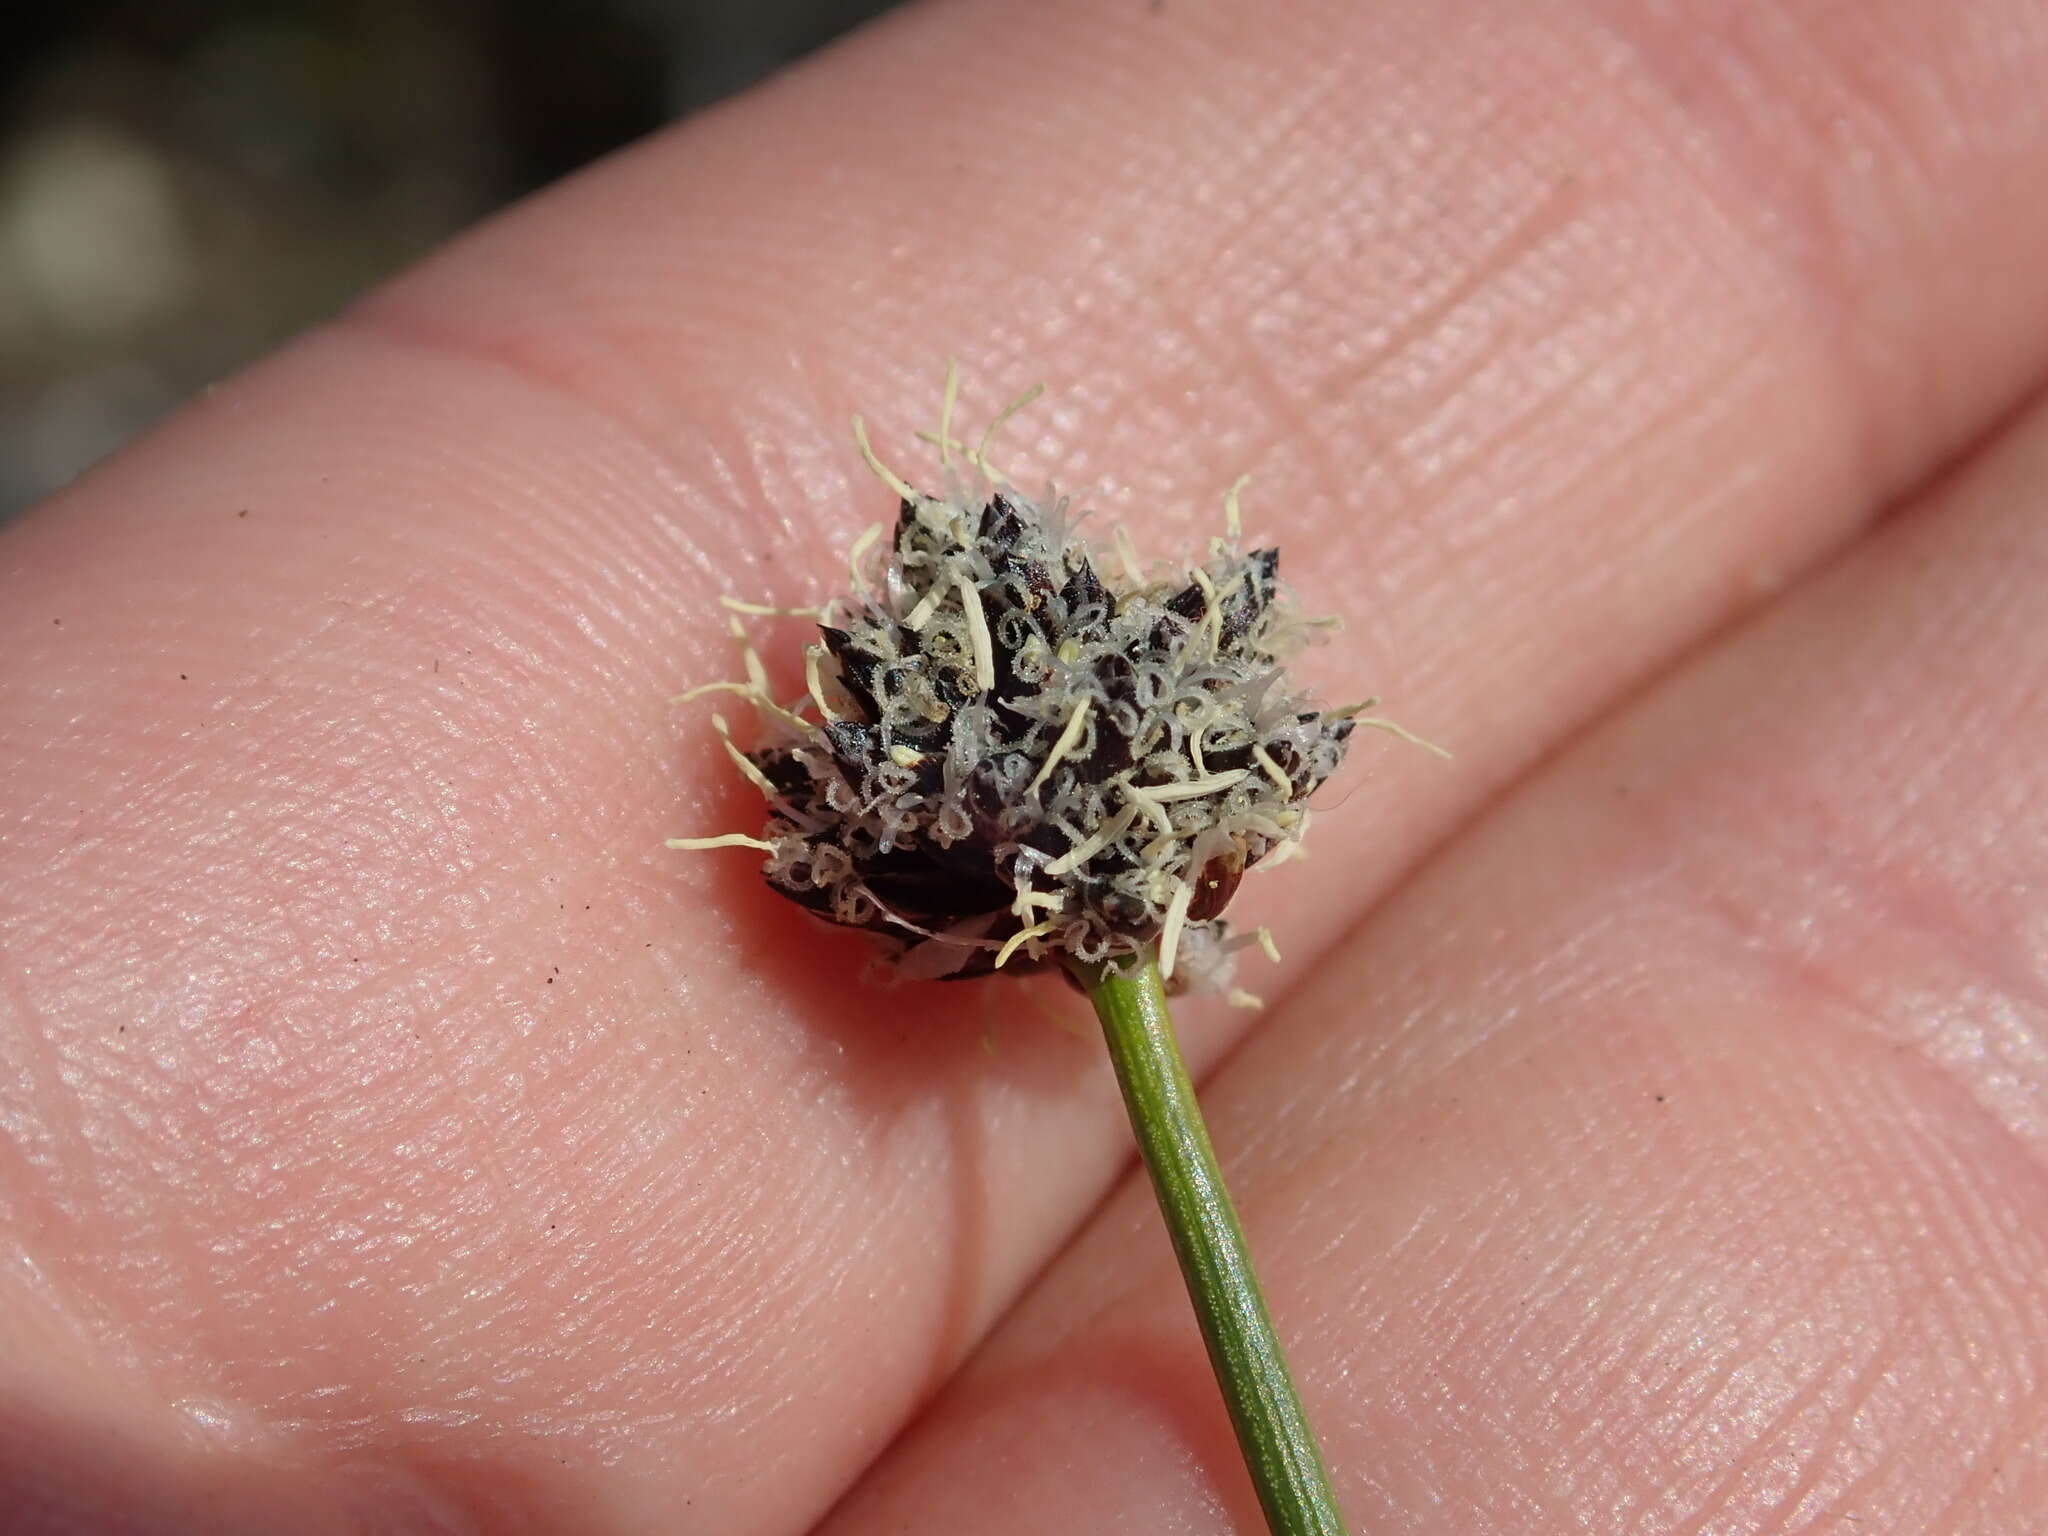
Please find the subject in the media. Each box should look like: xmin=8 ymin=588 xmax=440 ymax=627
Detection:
xmin=672 ymin=379 xmax=1397 ymax=997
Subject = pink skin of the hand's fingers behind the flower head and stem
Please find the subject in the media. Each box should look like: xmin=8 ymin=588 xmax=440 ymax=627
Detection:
xmin=0 ymin=0 xmax=2048 ymax=1536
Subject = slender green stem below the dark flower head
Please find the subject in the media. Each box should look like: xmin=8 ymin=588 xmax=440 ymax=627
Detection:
xmin=1073 ymin=954 xmax=1343 ymax=1536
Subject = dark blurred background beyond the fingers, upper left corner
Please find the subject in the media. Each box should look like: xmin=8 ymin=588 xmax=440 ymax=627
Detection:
xmin=0 ymin=0 xmax=893 ymax=522
